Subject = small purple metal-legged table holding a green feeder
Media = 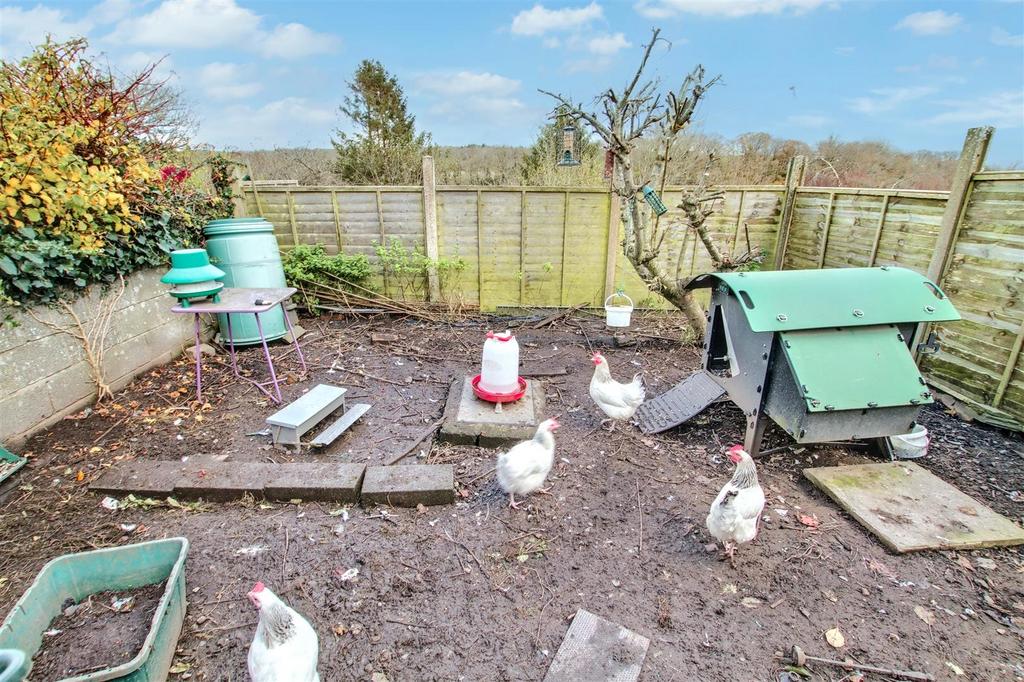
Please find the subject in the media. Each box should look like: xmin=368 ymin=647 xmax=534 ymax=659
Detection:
xmin=171 ymin=287 xmax=306 ymax=404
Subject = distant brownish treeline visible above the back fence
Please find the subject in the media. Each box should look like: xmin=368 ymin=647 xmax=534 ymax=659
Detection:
xmin=232 ymin=133 xmax=970 ymax=189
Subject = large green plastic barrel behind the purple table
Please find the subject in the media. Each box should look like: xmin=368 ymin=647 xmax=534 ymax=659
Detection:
xmin=203 ymin=218 xmax=288 ymax=345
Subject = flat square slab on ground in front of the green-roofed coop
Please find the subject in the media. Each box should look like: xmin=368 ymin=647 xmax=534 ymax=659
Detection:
xmin=804 ymin=462 xmax=1024 ymax=553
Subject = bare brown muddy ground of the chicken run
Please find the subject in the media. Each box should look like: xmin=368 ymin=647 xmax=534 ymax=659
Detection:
xmin=0 ymin=315 xmax=1024 ymax=682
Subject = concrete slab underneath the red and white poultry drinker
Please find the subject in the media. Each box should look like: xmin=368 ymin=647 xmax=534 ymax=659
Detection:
xmin=437 ymin=377 xmax=544 ymax=447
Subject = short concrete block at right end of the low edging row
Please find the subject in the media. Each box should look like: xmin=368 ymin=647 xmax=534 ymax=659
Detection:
xmin=360 ymin=464 xmax=455 ymax=507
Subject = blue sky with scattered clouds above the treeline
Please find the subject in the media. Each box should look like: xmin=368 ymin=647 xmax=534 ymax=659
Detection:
xmin=0 ymin=0 xmax=1024 ymax=166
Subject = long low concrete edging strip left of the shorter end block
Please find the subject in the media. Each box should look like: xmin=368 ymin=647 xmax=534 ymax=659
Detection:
xmin=89 ymin=460 xmax=366 ymax=502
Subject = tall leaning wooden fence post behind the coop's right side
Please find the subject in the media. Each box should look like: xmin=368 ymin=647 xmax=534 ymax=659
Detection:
xmin=910 ymin=126 xmax=995 ymax=360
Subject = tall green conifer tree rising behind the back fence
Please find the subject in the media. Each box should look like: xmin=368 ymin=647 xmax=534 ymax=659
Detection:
xmin=332 ymin=59 xmax=432 ymax=184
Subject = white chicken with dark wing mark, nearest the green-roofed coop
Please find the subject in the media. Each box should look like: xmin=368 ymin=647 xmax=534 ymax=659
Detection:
xmin=707 ymin=445 xmax=765 ymax=565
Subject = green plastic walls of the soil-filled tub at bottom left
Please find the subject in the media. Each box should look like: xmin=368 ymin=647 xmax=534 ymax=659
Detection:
xmin=0 ymin=538 xmax=188 ymax=682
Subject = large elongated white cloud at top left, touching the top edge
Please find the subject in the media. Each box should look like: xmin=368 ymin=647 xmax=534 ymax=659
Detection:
xmin=110 ymin=0 xmax=339 ymax=57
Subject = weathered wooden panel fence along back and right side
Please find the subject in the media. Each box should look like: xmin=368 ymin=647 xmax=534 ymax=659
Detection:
xmin=244 ymin=128 xmax=1024 ymax=430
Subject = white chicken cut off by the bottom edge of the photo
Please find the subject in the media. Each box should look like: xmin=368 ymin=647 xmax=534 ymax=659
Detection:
xmin=247 ymin=583 xmax=319 ymax=682
